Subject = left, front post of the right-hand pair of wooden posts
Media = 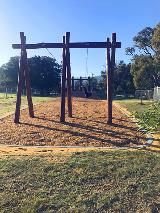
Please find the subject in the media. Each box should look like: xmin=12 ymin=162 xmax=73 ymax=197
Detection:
xmin=106 ymin=38 xmax=112 ymax=124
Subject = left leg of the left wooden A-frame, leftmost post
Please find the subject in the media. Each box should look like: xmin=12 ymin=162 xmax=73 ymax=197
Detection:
xmin=14 ymin=33 xmax=24 ymax=123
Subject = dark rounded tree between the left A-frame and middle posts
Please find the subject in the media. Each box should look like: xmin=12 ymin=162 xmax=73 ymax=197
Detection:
xmin=28 ymin=56 xmax=61 ymax=96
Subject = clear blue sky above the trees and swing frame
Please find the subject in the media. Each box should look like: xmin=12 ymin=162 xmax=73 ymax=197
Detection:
xmin=0 ymin=0 xmax=160 ymax=76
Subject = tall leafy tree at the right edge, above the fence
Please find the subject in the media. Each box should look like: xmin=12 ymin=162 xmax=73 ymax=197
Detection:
xmin=126 ymin=24 xmax=160 ymax=89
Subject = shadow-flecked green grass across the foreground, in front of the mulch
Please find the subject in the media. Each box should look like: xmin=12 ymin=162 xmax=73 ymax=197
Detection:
xmin=0 ymin=150 xmax=160 ymax=213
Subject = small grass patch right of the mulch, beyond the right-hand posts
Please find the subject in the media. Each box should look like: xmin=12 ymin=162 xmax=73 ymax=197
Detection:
xmin=113 ymin=99 xmax=153 ymax=113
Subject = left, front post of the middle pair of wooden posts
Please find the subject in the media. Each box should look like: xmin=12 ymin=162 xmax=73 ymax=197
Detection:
xmin=60 ymin=36 xmax=66 ymax=123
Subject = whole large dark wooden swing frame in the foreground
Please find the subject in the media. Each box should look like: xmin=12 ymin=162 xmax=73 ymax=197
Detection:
xmin=12 ymin=32 xmax=121 ymax=124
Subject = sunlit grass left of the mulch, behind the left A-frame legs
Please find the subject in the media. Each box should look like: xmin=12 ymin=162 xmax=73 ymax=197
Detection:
xmin=0 ymin=93 xmax=51 ymax=117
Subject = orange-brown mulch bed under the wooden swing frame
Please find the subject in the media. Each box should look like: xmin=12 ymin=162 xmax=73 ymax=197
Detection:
xmin=0 ymin=98 xmax=145 ymax=146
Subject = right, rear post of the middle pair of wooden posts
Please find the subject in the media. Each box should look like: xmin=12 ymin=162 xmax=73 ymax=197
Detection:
xmin=66 ymin=32 xmax=72 ymax=117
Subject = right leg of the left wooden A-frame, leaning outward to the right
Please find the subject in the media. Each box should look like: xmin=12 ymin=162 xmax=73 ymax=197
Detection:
xmin=21 ymin=33 xmax=34 ymax=118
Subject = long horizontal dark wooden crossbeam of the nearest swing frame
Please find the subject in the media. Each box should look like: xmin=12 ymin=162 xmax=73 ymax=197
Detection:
xmin=12 ymin=42 xmax=121 ymax=49
